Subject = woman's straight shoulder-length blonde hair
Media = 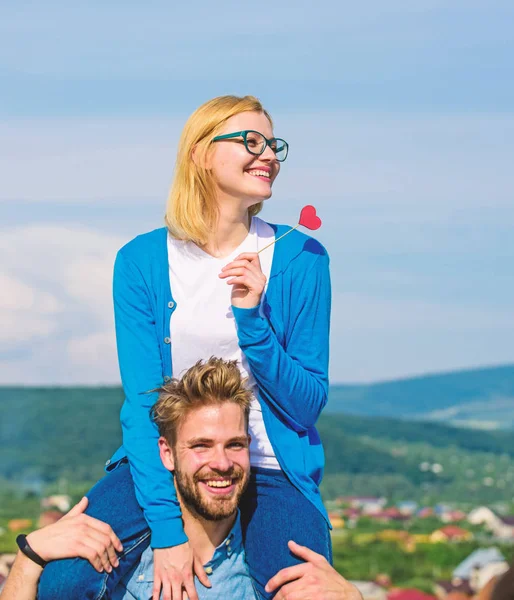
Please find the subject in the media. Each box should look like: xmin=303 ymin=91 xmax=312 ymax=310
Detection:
xmin=164 ymin=96 xmax=273 ymax=246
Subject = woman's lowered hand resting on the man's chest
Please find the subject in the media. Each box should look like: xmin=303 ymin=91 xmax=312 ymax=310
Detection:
xmin=152 ymin=542 xmax=211 ymax=600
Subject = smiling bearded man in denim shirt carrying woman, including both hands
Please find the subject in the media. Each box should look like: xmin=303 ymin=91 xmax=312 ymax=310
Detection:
xmin=1 ymin=359 xmax=360 ymax=600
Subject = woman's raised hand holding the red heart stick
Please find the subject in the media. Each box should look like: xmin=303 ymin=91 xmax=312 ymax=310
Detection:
xmin=219 ymin=252 xmax=266 ymax=308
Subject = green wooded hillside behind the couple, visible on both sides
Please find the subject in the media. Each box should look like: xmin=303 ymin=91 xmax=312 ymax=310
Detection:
xmin=0 ymin=387 xmax=514 ymax=503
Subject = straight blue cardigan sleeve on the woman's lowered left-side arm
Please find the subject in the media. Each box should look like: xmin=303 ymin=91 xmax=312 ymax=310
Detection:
xmin=113 ymin=250 xmax=187 ymax=548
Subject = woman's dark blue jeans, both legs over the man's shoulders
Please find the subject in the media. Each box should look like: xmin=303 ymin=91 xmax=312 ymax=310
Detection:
xmin=38 ymin=462 xmax=332 ymax=600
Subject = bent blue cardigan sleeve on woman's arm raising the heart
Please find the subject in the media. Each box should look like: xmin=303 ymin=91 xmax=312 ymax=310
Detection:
xmin=232 ymin=253 xmax=331 ymax=431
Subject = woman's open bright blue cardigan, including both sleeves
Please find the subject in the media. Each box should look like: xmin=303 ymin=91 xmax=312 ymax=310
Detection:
xmin=107 ymin=225 xmax=331 ymax=548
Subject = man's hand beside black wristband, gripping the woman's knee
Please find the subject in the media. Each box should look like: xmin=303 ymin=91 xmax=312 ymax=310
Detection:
xmin=27 ymin=497 xmax=123 ymax=573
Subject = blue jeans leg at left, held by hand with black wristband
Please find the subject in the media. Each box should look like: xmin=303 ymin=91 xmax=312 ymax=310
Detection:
xmin=38 ymin=462 xmax=150 ymax=600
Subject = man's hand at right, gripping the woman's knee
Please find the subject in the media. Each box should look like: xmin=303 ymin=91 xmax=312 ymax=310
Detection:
xmin=266 ymin=541 xmax=362 ymax=600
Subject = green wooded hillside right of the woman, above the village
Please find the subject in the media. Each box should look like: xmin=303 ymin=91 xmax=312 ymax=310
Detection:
xmin=318 ymin=414 xmax=514 ymax=505
